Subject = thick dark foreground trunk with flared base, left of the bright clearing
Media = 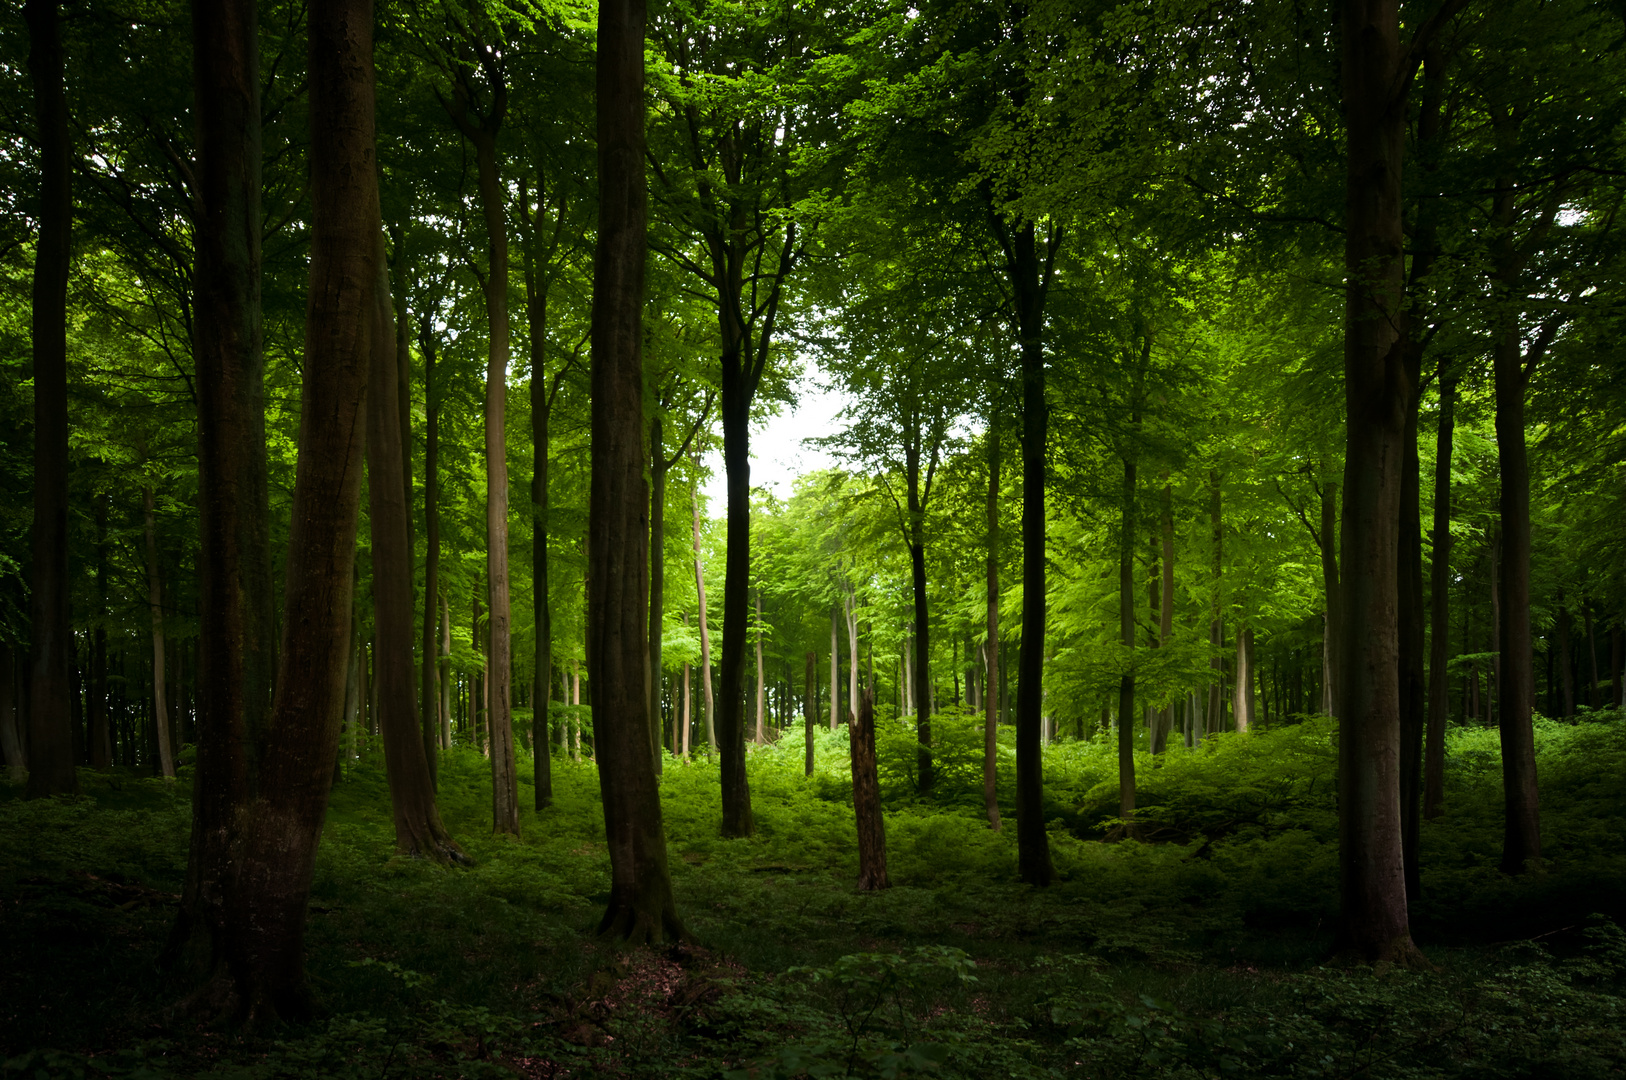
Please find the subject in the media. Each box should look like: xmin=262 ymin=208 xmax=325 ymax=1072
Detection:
xmin=587 ymin=0 xmax=682 ymax=943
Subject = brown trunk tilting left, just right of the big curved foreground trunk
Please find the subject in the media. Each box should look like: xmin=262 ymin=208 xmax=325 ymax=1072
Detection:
xmin=367 ymin=239 xmax=465 ymax=864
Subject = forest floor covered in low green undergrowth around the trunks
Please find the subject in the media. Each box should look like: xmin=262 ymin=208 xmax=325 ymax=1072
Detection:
xmin=0 ymin=712 xmax=1626 ymax=1080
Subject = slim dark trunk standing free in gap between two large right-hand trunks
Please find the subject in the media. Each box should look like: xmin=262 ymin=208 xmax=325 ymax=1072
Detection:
xmin=1423 ymin=359 xmax=1457 ymax=820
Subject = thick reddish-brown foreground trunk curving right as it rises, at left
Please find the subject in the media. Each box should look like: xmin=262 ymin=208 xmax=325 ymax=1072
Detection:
xmin=224 ymin=0 xmax=379 ymax=1023
